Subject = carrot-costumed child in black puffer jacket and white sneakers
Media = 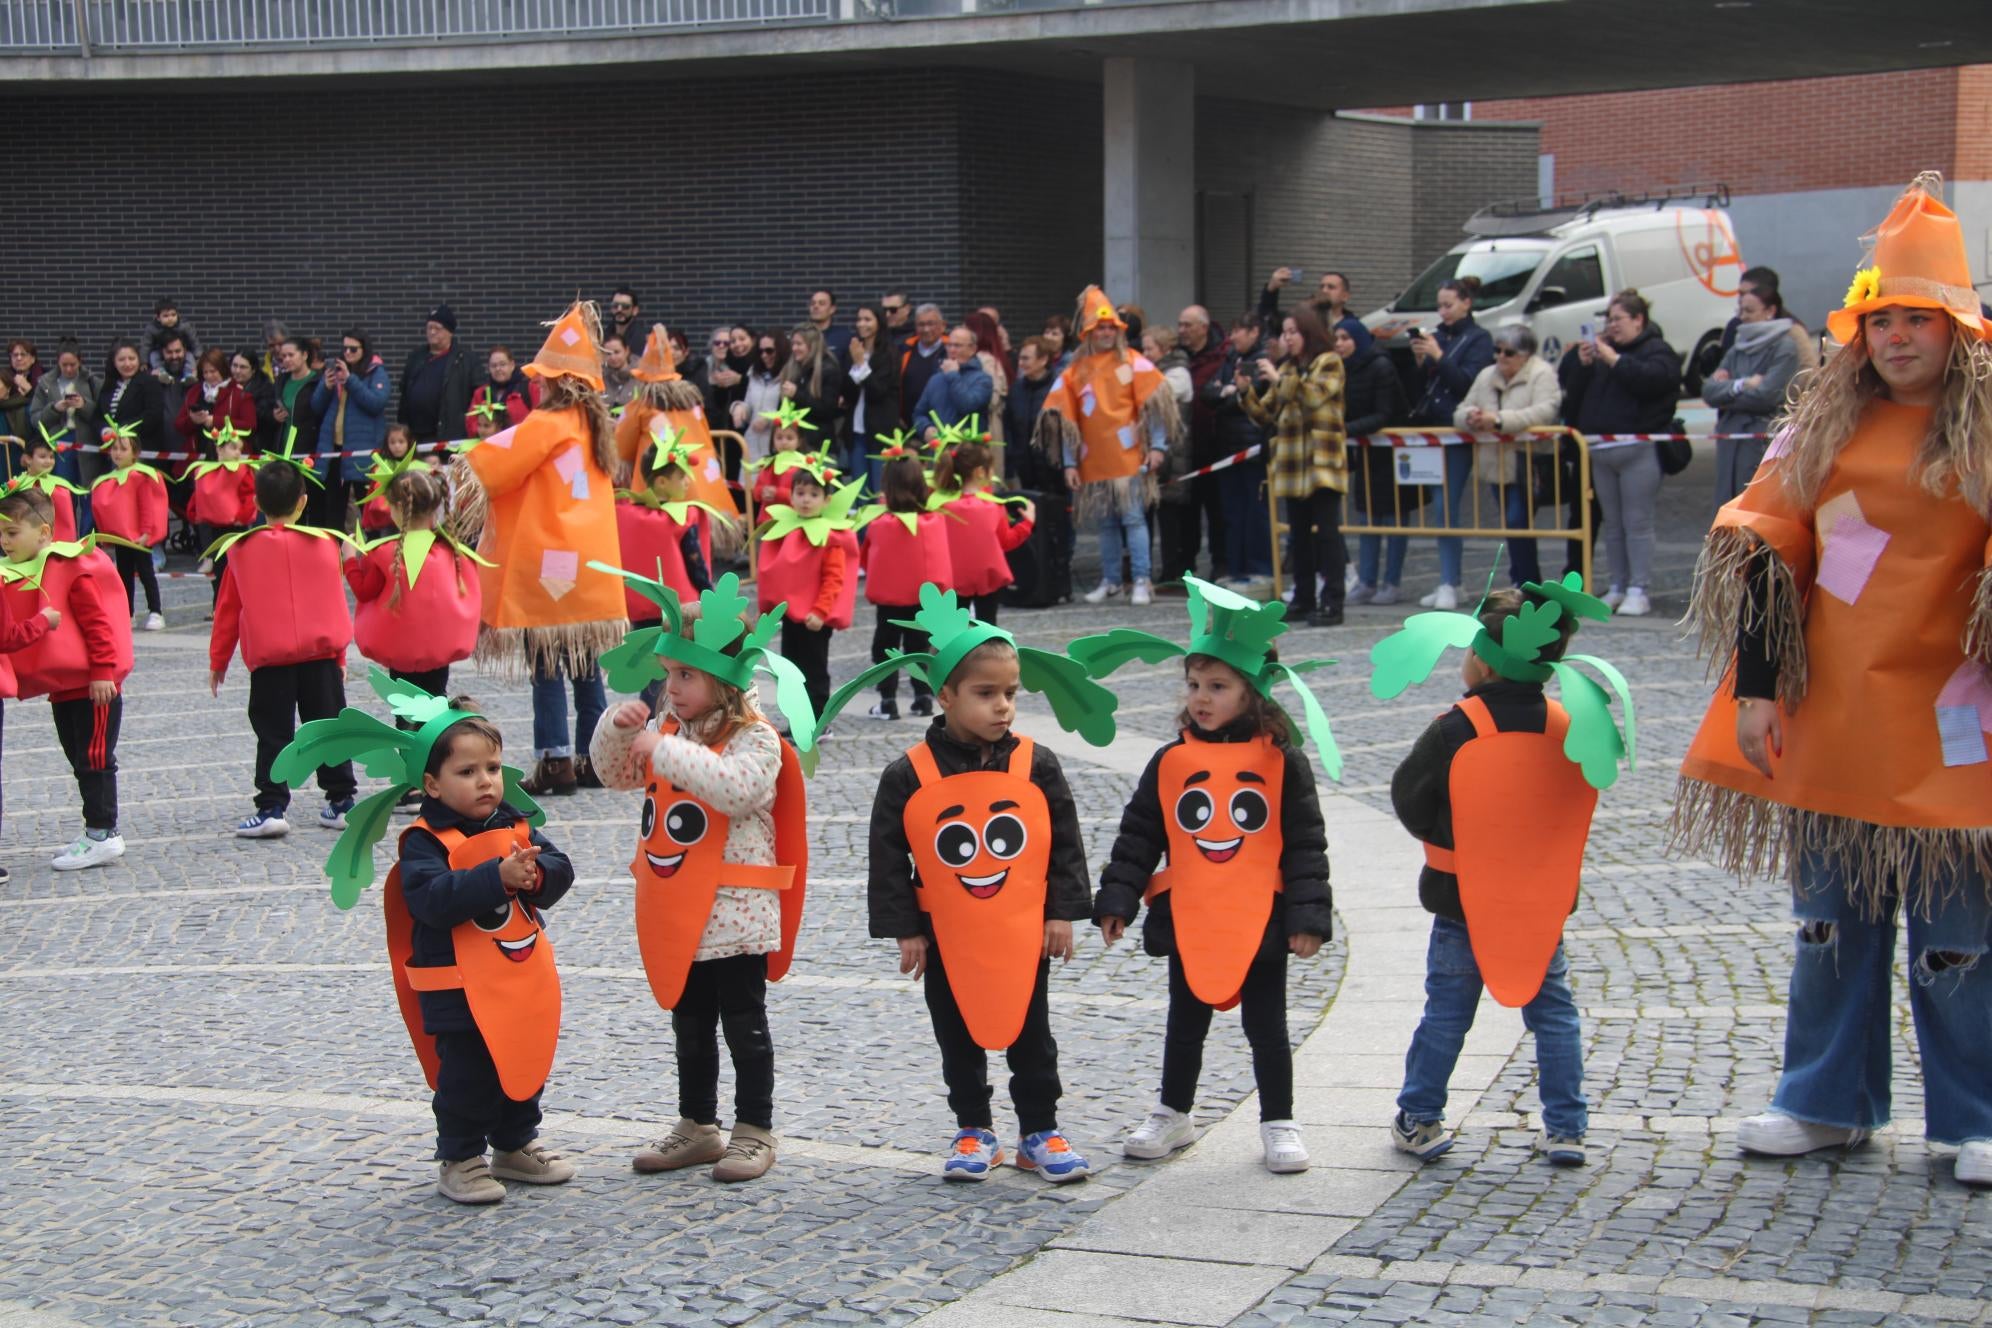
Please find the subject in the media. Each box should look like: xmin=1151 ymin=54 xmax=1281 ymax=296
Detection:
xmin=1070 ymin=575 xmax=1343 ymax=1173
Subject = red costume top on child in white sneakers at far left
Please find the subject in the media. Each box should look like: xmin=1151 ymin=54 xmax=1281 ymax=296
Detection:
xmin=0 ymin=550 xmax=131 ymax=701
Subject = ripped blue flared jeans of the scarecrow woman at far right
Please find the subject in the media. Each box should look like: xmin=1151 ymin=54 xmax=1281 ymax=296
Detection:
xmin=1771 ymin=854 xmax=1992 ymax=1143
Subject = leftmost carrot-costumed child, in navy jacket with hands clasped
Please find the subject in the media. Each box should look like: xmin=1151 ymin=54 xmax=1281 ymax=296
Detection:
xmin=277 ymin=669 xmax=574 ymax=1205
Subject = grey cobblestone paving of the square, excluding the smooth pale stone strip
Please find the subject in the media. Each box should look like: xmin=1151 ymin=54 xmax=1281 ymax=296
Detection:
xmin=0 ymin=449 xmax=1992 ymax=1328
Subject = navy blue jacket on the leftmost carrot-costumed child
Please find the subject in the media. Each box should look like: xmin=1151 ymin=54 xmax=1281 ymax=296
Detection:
xmin=400 ymin=798 xmax=574 ymax=1033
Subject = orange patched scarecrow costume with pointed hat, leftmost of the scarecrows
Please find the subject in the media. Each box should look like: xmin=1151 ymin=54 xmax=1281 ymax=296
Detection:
xmin=452 ymin=305 xmax=627 ymax=675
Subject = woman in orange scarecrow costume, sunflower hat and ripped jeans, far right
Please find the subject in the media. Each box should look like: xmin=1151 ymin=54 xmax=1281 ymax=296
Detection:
xmin=1673 ymin=173 xmax=1992 ymax=1162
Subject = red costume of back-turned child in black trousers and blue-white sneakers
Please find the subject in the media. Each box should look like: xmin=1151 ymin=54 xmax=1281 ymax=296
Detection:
xmin=207 ymin=526 xmax=353 ymax=673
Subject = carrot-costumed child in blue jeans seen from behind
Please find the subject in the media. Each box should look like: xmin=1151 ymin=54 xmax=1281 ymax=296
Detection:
xmin=1370 ymin=571 xmax=1633 ymax=1167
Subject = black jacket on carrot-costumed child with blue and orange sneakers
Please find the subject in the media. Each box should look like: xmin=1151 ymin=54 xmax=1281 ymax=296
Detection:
xmin=867 ymin=715 xmax=1094 ymax=940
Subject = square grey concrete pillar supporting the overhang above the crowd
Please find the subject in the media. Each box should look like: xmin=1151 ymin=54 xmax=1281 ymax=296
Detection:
xmin=1104 ymin=56 xmax=1197 ymax=327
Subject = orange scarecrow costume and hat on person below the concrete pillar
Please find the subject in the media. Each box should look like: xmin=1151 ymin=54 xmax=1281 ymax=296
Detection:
xmin=1034 ymin=287 xmax=1177 ymax=524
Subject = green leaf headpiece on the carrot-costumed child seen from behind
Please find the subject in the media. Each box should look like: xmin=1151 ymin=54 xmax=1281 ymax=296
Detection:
xmin=1370 ymin=571 xmax=1635 ymax=788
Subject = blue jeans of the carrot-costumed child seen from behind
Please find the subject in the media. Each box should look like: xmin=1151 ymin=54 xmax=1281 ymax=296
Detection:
xmin=1396 ymin=918 xmax=1590 ymax=1139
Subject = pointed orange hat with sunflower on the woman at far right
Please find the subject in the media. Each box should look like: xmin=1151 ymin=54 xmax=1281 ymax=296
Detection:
xmin=1827 ymin=171 xmax=1992 ymax=344
